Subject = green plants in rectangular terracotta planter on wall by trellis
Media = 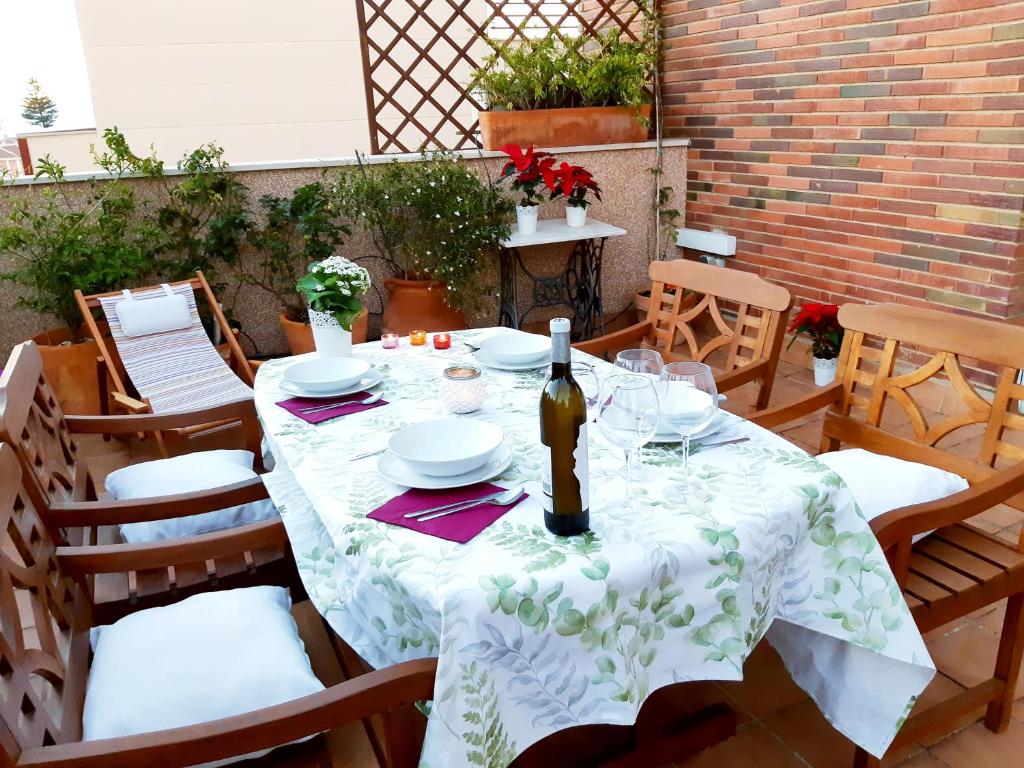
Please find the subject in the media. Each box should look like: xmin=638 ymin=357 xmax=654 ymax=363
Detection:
xmin=470 ymin=30 xmax=657 ymax=150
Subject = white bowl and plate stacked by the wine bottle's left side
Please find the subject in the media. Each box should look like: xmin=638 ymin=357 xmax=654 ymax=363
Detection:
xmin=377 ymin=419 xmax=512 ymax=488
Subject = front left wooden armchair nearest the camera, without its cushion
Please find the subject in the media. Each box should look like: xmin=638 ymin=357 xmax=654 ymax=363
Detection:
xmin=0 ymin=444 xmax=435 ymax=768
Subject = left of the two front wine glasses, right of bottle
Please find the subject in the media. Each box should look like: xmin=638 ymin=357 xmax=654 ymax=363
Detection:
xmin=597 ymin=374 xmax=660 ymax=507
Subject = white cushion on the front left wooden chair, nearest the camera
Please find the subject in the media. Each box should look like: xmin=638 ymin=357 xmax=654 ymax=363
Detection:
xmin=82 ymin=587 xmax=324 ymax=766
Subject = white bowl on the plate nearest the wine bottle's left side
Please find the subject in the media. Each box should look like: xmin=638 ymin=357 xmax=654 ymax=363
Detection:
xmin=388 ymin=419 xmax=505 ymax=477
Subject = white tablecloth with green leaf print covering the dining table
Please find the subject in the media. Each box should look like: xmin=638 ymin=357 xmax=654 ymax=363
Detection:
xmin=255 ymin=329 xmax=935 ymax=768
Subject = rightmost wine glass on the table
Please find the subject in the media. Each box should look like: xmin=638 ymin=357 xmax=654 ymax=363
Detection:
xmin=658 ymin=362 xmax=718 ymax=498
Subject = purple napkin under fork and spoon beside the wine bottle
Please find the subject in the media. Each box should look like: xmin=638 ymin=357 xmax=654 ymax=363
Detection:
xmin=367 ymin=482 xmax=527 ymax=544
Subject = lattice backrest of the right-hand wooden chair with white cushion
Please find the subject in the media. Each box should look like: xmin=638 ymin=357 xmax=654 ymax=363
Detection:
xmin=821 ymin=304 xmax=1024 ymax=481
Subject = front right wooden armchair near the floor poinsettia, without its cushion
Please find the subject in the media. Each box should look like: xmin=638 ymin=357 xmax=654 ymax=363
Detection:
xmin=751 ymin=304 xmax=1024 ymax=766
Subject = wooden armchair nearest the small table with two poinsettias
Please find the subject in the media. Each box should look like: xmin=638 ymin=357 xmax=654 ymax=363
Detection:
xmin=574 ymin=259 xmax=793 ymax=410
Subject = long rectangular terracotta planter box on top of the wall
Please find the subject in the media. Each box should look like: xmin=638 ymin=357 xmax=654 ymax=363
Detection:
xmin=480 ymin=104 xmax=650 ymax=150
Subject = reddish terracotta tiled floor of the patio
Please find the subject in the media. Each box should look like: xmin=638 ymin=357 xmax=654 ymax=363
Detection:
xmin=75 ymin=361 xmax=1024 ymax=768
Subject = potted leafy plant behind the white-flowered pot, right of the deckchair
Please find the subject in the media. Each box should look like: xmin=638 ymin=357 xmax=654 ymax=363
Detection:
xmin=234 ymin=180 xmax=368 ymax=354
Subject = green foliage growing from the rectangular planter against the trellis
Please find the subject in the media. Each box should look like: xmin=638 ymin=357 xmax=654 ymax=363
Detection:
xmin=469 ymin=30 xmax=657 ymax=115
